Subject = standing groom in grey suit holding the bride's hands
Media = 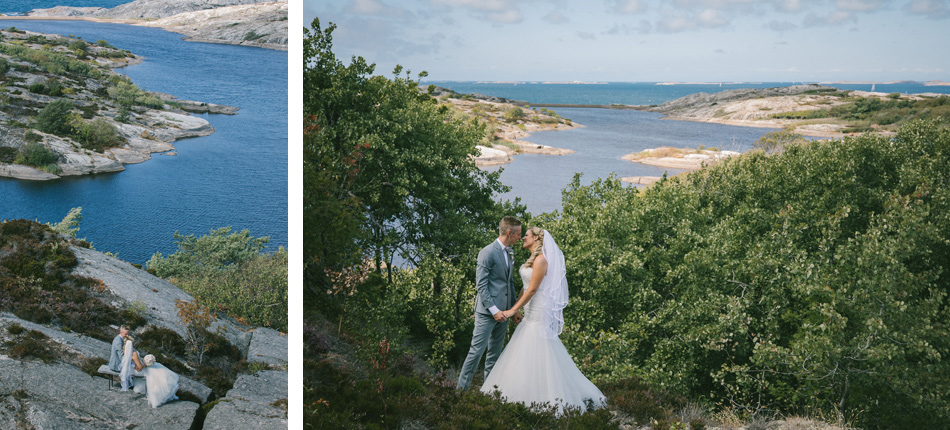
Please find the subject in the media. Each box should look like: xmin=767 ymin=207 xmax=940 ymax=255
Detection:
xmin=457 ymin=216 xmax=521 ymax=391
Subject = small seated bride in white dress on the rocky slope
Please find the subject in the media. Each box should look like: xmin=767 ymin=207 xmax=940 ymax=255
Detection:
xmin=119 ymin=336 xmax=178 ymax=409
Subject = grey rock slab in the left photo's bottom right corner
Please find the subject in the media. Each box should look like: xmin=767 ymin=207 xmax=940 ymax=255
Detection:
xmin=204 ymin=370 xmax=287 ymax=430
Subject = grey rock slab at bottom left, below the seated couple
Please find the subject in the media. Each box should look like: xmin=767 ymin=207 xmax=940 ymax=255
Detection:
xmin=0 ymin=357 xmax=198 ymax=430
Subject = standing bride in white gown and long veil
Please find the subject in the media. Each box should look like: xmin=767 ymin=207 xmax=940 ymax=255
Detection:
xmin=481 ymin=227 xmax=606 ymax=413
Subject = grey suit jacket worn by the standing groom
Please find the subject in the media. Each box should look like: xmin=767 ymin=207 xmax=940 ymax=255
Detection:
xmin=475 ymin=240 xmax=517 ymax=315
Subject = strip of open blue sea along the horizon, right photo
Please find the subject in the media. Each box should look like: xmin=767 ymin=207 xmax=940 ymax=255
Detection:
xmin=422 ymin=81 xmax=950 ymax=105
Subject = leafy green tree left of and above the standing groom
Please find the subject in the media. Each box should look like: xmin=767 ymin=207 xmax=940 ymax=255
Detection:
xmin=303 ymin=19 xmax=523 ymax=291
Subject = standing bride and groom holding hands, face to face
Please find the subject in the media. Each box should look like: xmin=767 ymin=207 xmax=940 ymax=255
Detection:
xmin=457 ymin=216 xmax=605 ymax=413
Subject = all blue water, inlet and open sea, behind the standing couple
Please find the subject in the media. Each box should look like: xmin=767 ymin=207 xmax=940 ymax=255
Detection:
xmin=423 ymin=82 xmax=950 ymax=214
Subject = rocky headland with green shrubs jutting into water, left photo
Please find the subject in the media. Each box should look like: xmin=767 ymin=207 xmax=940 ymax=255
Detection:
xmin=0 ymin=27 xmax=238 ymax=180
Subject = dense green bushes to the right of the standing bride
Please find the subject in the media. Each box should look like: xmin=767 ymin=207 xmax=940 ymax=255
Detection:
xmin=539 ymin=121 xmax=950 ymax=428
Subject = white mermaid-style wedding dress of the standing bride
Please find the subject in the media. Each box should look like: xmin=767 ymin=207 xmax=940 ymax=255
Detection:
xmin=481 ymin=264 xmax=605 ymax=414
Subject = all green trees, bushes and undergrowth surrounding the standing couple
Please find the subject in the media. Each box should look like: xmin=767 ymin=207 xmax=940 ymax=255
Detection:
xmin=303 ymin=15 xmax=950 ymax=429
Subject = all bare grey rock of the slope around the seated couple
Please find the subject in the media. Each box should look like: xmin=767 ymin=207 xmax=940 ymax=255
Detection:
xmin=0 ymin=242 xmax=288 ymax=430
